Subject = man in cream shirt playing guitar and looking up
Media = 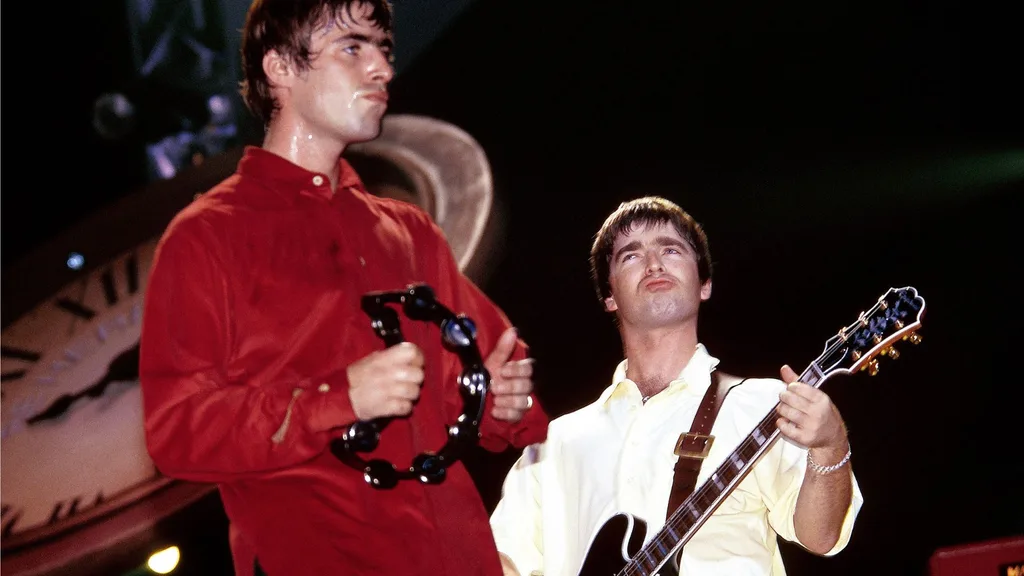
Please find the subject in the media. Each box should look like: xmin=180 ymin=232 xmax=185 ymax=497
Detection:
xmin=490 ymin=197 xmax=863 ymax=576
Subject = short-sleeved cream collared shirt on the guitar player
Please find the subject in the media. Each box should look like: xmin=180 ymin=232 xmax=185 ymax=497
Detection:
xmin=490 ymin=344 xmax=863 ymax=576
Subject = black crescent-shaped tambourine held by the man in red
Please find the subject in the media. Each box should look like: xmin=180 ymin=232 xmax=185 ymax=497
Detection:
xmin=331 ymin=284 xmax=490 ymax=489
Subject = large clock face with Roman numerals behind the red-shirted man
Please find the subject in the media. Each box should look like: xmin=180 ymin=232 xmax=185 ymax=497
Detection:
xmin=0 ymin=239 xmax=166 ymax=551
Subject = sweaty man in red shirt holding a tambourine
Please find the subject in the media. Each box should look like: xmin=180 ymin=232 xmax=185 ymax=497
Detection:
xmin=140 ymin=0 xmax=548 ymax=576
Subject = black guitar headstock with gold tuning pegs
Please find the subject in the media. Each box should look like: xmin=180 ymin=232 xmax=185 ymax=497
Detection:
xmin=814 ymin=286 xmax=925 ymax=377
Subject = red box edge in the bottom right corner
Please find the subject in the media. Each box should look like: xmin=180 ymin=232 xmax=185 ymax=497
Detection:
xmin=929 ymin=536 xmax=1024 ymax=576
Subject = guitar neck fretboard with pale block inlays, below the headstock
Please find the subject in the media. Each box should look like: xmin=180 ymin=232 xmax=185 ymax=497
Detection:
xmin=620 ymin=362 xmax=825 ymax=575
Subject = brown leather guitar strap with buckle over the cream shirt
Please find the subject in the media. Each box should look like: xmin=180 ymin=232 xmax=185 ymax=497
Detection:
xmin=666 ymin=370 xmax=733 ymax=517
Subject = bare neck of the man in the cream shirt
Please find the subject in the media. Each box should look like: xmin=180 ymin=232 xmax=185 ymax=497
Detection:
xmin=621 ymin=325 xmax=697 ymax=397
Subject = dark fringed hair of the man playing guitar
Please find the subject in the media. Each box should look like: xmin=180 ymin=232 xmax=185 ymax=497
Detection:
xmin=590 ymin=196 xmax=712 ymax=301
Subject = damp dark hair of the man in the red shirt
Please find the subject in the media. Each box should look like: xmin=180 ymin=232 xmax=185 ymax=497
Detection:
xmin=241 ymin=0 xmax=392 ymax=124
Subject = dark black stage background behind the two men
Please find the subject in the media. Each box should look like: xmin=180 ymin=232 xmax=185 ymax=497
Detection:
xmin=2 ymin=0 xmax=1024 ymax=576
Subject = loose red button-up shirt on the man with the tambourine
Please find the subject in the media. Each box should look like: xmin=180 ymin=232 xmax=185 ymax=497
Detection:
xmin=140 ymin=148 xmax=548 ymax=576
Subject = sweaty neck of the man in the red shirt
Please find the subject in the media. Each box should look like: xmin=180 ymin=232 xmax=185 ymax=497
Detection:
xmin=263 ymin=112 xmax=345 ymax=190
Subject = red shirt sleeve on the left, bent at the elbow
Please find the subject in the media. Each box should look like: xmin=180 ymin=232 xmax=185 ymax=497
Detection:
xmin=139 ymin=218 xmax=355 ymax=482
